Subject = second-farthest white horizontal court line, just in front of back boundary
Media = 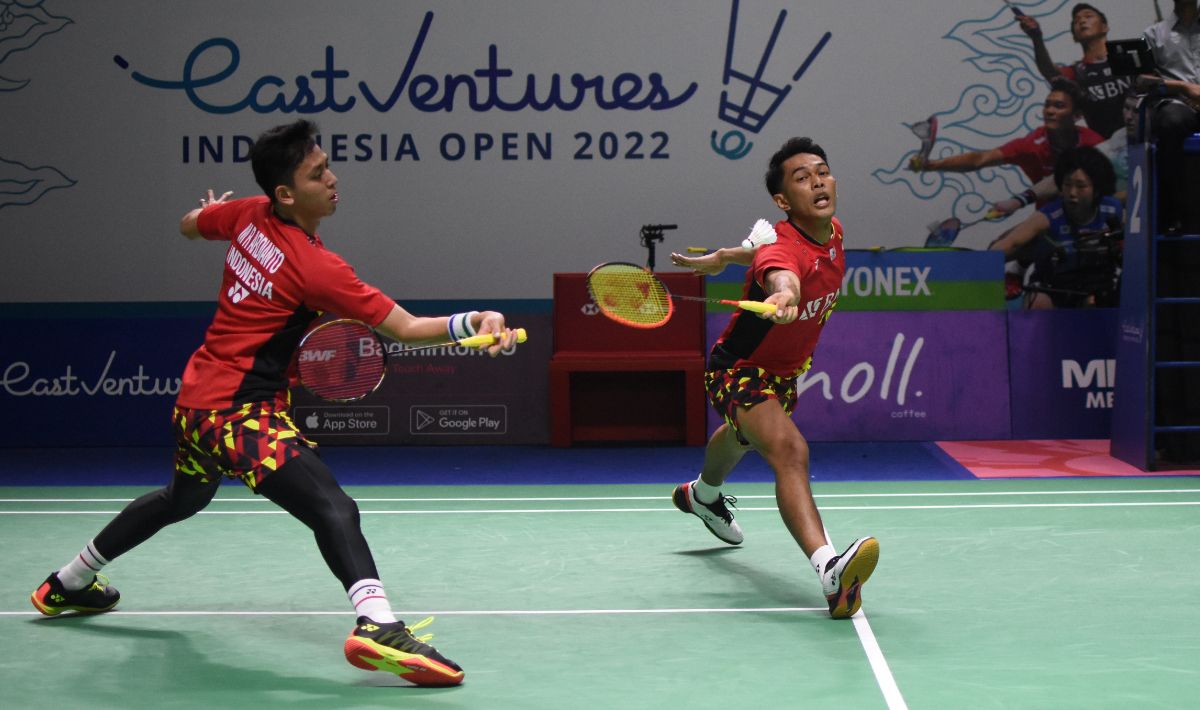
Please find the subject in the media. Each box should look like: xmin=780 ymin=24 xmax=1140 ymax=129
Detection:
xmin=0 ymin=500 xmax=1200 ymax=516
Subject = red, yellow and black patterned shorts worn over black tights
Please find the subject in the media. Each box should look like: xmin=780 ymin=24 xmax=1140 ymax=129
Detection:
xmin=174 ymin=402 xmax=317 ymax=491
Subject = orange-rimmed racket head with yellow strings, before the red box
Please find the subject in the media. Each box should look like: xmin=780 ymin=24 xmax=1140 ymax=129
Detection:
xmin=587 ymin=261 xmax=674 ymax=329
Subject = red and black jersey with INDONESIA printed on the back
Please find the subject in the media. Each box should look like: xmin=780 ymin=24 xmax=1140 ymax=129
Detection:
xmin=175 ymin=195 xmax=395 ymax=409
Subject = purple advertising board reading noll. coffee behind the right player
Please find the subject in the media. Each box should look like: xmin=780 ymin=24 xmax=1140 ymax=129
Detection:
xmin=708 ymin=311 xmax=1009 ymax=441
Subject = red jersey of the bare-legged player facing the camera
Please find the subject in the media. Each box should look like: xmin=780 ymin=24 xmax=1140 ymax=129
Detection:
xmin=714 ymin=217 xmax=846 ymax=378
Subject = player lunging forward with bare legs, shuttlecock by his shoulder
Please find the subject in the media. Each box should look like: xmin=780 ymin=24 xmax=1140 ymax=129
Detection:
xmin=671 ymin=138 xmax=880 ymax=619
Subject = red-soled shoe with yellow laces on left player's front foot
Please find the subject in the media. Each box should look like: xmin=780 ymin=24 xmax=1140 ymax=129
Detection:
xmin=346 ymin=616 xmax=463 ymax=686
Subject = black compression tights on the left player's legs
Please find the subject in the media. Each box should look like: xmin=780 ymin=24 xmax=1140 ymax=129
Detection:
xmin=95 ymin=449 xmax=379 ymax=589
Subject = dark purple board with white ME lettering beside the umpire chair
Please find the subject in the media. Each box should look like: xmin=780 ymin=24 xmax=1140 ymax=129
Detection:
xmin=1008 ymin=308 xmax=1117 ymax=439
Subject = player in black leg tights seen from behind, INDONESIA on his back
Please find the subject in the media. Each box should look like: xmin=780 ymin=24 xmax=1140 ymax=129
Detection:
xmin=31 ymin=120 xmax=516 ymax=685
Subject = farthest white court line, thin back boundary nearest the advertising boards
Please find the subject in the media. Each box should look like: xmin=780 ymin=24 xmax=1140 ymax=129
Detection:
xmin=7 ymin=488 xmax=1200 ymax=504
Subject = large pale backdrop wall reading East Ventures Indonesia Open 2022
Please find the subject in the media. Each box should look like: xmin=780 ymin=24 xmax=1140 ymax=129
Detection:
xmin=0 ymin=0 xmax=1152 ymax=307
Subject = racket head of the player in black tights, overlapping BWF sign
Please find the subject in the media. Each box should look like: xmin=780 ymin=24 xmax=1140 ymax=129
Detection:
xmin=296 ymin=318 xmax=388 ymax=402
